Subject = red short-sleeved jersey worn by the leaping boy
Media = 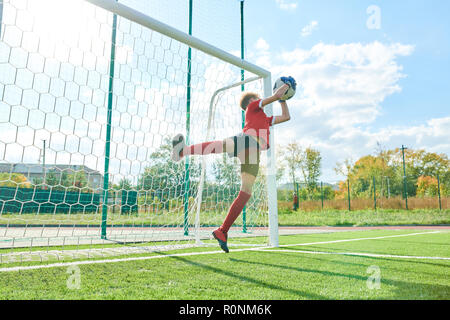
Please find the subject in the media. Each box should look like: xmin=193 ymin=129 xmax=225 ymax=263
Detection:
xmin=243 ymin=99 xmax=274 ymax=150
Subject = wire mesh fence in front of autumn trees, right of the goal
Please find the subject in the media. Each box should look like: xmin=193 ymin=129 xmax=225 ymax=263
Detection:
xmin=278 ymin=176 xmax=450 ymax=211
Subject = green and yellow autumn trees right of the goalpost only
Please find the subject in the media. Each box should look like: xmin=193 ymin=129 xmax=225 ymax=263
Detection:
xmin=277 ymin=142 xmax=450 ymax=200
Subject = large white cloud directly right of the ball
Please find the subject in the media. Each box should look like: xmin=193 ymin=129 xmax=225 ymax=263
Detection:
xmin=271 ymin=42 xmax=414 ymax=128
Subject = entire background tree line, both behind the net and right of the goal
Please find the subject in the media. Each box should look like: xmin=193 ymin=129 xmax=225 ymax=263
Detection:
xmin=0 ymin=140 xmax=450 ymax=201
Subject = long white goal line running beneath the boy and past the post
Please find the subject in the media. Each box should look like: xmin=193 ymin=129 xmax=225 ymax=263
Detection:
xmin=0 ymin=231 xmax=441 ymax=272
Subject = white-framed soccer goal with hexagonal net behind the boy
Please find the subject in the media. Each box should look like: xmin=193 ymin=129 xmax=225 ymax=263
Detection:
xmin=0 ymin=0 xmax=278 ymax=263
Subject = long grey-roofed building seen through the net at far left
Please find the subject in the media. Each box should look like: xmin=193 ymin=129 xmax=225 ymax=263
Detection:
xmin=0 ymin=163 xmax=103 ymax=190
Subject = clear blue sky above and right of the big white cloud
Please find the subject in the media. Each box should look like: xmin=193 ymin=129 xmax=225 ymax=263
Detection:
xmin=245 ymin=0 xmax=450 ymax=126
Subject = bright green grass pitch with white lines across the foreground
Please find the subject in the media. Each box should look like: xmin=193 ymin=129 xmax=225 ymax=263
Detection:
xmin=0 ymin=230 xmax=450 ymax=300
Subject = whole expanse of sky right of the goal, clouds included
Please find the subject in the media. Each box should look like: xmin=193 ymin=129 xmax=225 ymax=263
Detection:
xmin=239 ymin=0 xmax=450 ymax=180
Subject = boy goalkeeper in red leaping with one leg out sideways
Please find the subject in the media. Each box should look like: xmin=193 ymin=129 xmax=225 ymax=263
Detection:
xmin=172 ymin=77 xmax=297 ymax=252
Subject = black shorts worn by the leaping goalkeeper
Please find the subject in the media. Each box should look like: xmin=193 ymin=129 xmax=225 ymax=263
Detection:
xmin=228 ymin=133 xmax=261 ymax=177
